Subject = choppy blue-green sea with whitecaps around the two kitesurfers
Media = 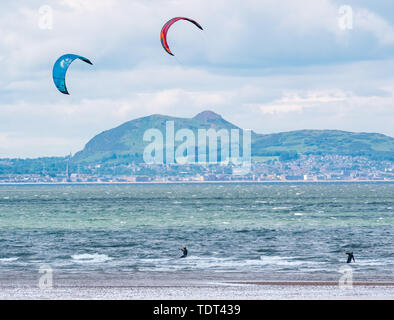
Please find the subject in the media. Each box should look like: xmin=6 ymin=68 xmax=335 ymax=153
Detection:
xmin=0 ymin=183 xmax=394 ymax=281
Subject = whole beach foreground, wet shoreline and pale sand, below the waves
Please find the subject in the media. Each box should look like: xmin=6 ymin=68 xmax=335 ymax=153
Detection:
xmin=0 ymin=274 xmax=394 ymax=300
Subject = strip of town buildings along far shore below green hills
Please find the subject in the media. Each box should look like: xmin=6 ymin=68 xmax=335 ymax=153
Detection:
xmin=0 ymin=155 xmax=394 ymax=184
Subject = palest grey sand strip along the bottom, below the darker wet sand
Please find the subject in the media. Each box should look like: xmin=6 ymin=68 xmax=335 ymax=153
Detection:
xmin=0 ymin=284 xmax=394 ymax=300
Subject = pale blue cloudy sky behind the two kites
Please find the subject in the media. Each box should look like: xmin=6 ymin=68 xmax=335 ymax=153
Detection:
xmin=0 ymin=0 xmax=394 ymax=158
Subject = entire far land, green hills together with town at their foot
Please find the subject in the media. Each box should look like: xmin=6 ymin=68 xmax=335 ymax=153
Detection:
xmin=0 ymin=110 xmax=394 ymax=184
